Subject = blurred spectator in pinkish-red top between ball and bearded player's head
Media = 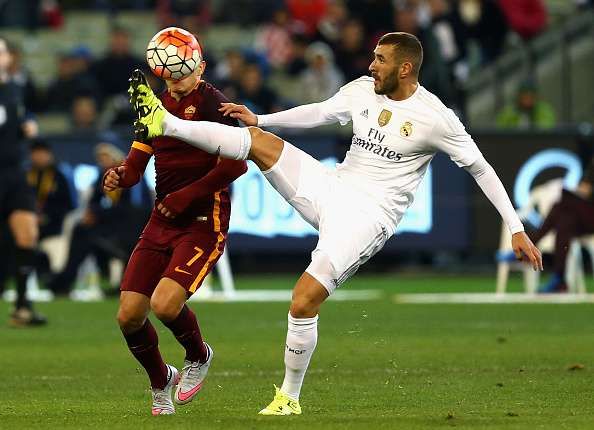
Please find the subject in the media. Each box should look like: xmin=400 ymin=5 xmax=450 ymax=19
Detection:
xmin=255 ymin=8 xmax=293 ymax=69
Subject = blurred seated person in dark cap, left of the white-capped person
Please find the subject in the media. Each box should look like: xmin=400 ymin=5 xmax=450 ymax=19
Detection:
xmin=27 ymin=139 xmax=76 ymax=239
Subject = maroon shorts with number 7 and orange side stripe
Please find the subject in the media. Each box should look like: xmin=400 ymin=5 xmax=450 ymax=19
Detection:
xmin=121 ymin=217 xmax=227 ymax=297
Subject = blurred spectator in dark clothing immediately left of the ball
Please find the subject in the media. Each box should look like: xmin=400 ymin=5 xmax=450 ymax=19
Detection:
xmin=92 ymin=27 xmax=144 ymax=99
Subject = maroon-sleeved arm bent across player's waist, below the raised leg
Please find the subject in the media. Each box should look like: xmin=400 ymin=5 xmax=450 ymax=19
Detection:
xmin=157 ymin=158 xmax=247 ymax=218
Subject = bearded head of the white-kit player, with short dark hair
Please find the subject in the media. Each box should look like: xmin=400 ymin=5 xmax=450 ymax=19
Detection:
xmin=369 ymin=32 xmax=423 ymax=94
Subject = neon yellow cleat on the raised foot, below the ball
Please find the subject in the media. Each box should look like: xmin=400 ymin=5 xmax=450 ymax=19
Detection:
xmin=128 ymin=69 xmax=166 ymax=139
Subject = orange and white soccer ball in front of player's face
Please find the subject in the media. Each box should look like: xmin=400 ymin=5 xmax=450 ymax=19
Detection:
xmin=146 ymin=27 xmax=202 ymax=80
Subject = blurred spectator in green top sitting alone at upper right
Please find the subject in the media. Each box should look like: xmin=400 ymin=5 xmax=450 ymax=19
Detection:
xmin=497 ymin=80 xmax=556 ymax=129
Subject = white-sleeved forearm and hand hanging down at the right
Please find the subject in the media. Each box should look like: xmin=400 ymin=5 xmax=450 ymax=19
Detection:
xmin=465 ymin=156 xmax=543 ymax=270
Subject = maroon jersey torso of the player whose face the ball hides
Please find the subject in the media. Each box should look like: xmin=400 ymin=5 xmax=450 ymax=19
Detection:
xmin=151 ymin=81 xmax=238 ymax=231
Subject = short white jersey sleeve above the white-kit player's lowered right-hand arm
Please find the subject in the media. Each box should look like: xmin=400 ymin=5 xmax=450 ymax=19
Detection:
xmin=429 ymin=109 xmax=482 ymax=167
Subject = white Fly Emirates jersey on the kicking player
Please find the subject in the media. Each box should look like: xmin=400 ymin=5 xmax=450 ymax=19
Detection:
xmin=320 ymin=76 xmax=481 ymax=230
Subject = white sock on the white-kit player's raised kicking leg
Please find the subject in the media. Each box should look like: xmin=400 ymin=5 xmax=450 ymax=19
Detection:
xmin=163 ymin=113 xmax=252 ymax=160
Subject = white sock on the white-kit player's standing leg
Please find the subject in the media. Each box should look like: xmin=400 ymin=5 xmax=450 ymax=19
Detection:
xmin=281 ymin=314 xmax=318 ymax=400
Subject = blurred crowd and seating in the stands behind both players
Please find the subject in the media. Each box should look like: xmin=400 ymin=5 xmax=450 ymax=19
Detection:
xmin=0 ymin=0 xmax=594 ymax=135
